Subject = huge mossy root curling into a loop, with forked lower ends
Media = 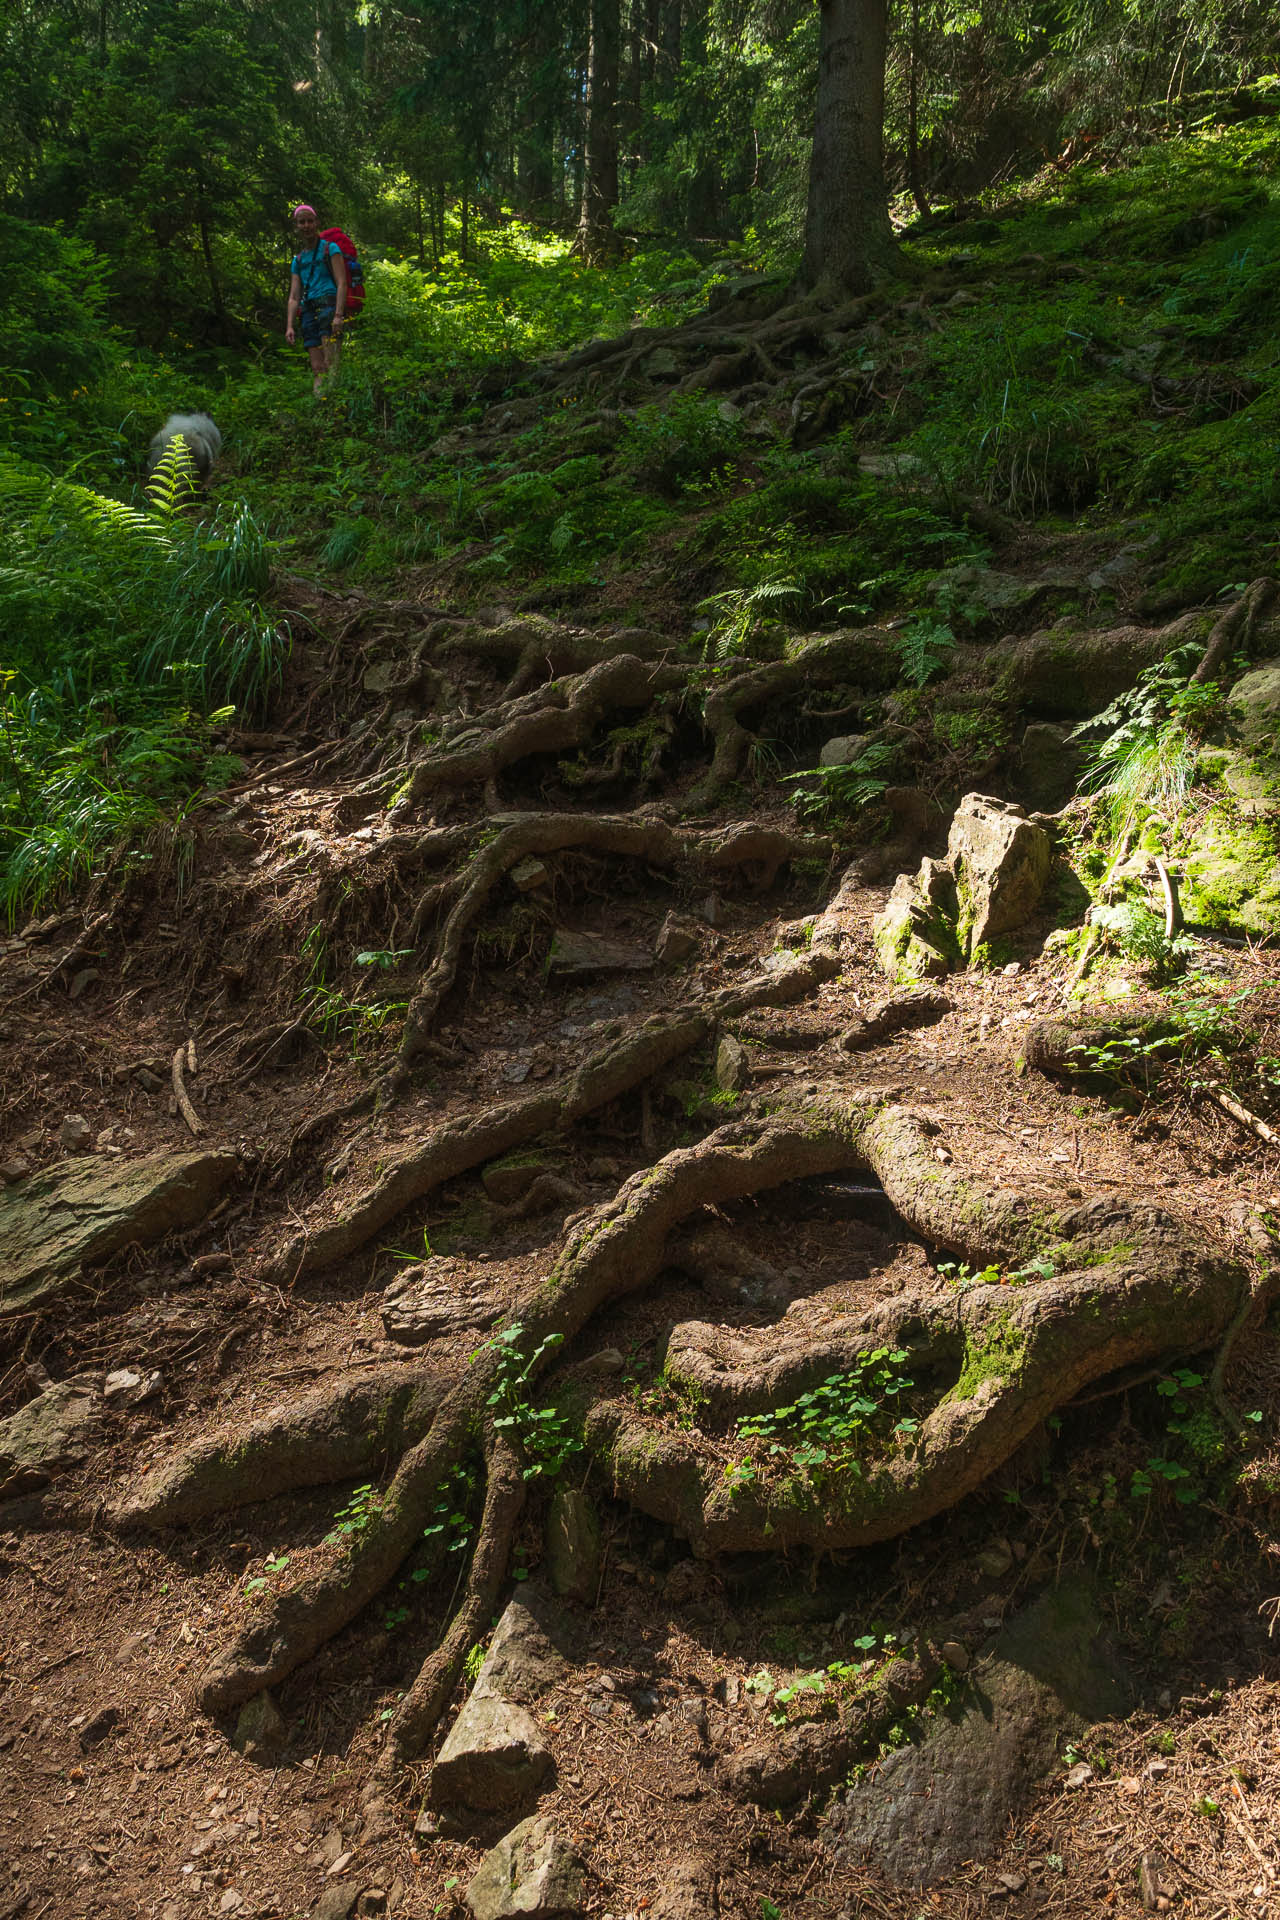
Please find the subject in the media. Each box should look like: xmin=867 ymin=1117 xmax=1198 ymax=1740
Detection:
xmin=185 ymin=1098 xmax=1244 ymax=1759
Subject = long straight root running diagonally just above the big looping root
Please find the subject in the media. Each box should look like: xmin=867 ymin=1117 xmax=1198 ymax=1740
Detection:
xmin=263 ymin=947 xmax=841 ymax=1284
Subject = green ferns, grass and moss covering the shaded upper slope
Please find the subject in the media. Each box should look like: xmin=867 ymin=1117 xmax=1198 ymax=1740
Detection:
xmin=0 ymin=117 xmax=1280 ymax=912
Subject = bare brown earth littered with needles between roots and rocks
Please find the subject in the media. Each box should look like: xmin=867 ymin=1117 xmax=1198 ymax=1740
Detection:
xmin=0 ymin=572 xmax=1280 ymax=1920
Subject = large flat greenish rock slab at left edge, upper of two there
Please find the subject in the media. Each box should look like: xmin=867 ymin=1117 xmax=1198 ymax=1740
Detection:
xmin=0 ymin=1152 xmax=236 ymax=1319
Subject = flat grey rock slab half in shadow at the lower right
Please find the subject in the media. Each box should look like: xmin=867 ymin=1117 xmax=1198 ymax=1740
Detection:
xmin=825 ymin=1580 xmax=1130 ymax=1885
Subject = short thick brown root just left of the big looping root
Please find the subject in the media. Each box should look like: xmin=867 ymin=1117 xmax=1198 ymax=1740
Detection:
xmin=107 ymin=1367 xmax=445 ymax=1528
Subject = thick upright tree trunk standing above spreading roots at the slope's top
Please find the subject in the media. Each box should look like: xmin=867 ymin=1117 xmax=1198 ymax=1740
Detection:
xmin=800 ymin=0 xmax=894 ymax=296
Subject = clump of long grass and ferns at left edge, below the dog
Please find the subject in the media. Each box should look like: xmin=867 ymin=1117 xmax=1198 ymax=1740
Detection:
xmin=0 ymin=455 xmax=286 ymax=924
